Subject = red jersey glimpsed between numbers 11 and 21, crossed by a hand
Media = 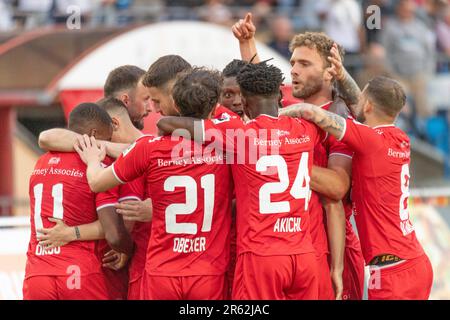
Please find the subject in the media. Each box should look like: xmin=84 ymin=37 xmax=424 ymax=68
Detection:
xmin=119 ymin=176 xmax=152 ymax=282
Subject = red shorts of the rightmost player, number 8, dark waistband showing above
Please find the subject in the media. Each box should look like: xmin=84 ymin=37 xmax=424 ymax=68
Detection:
xmin=368 ymin=254 xmax=433 ymax=300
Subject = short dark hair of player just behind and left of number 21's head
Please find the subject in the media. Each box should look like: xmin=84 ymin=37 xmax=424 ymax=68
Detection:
xmin=142 ymin=54 xmax=191 ymax=88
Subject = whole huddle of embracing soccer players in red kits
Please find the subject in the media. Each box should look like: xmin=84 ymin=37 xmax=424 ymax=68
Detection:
xmin=23 ymin=14 xmax=433 ymax=300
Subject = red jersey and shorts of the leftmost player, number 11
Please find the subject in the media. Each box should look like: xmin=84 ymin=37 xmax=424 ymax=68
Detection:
xmin=23 ymin=152 xmax=108 ymax=300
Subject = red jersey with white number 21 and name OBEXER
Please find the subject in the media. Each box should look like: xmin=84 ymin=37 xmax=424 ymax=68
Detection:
xmin=113 ymin=136 xmax=232 ymax=276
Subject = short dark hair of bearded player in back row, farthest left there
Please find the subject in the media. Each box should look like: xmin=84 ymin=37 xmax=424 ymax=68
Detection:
xmin=103 ymin=65 xmax=145 ymax=97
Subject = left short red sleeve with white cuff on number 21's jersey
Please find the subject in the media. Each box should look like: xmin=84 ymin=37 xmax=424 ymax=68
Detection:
xmin=112 ymin=137 xmax=158 ymax=184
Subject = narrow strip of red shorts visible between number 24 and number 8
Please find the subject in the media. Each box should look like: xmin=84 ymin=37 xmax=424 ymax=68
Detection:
xmin=342 ymin=247 xmax=364 ymax=300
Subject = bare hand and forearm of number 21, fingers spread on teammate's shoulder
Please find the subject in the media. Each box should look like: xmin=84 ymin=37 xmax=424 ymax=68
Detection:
xmin=74 ymin=135 xmax=121 ymax=192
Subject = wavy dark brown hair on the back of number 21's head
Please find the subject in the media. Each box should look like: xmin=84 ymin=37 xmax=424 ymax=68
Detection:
xmin=172 ymin=68 xmax=222 ymax=119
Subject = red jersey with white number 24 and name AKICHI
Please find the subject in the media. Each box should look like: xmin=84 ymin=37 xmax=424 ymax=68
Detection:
xmin=203 ymin=115 xmax=318 ymax=256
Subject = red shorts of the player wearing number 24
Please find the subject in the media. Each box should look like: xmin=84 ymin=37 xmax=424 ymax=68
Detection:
xmin=232 ymin=252 xmax=318 ymax=300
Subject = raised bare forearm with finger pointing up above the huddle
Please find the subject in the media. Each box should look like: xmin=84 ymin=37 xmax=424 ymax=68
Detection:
xmin=231 ymin=12 xmax=259 ymax=63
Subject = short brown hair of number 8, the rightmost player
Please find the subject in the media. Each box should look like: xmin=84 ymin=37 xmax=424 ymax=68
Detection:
xmin=366 ymin=76 xmax=406 ymax=117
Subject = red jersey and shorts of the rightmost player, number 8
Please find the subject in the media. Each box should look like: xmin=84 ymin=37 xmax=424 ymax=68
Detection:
xmin=342 ymin=119 xmax=433 ymax=299
